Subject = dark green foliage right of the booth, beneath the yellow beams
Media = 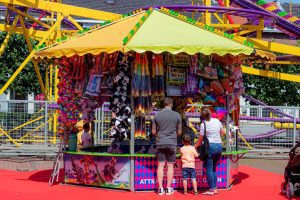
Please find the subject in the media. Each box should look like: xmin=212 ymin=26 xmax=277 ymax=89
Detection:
xmin=243 ymin=65 xmax=300 ymax=106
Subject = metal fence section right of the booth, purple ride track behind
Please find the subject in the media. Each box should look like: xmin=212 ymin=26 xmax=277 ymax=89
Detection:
xmin=239 ymin=106 xmax=300 ymax=153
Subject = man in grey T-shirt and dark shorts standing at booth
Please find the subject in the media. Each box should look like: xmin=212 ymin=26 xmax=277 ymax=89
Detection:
xmin=152 ymin=98 xmax=181 ymax=195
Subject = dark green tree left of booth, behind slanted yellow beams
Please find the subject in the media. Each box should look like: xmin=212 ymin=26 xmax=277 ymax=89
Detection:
xmin=0 ymin=32 xmax=45 ymax=95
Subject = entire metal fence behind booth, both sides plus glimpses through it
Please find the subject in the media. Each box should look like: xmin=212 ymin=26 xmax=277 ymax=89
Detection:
xmin=0 ymin=101 xmax=300 ymax=155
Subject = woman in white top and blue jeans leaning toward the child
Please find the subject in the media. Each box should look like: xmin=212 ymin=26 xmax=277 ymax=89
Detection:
xmin=195 ymin=107 xmax=225 ymax=195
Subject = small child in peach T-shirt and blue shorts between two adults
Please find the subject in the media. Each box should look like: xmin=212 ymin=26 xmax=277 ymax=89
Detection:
xmin=180 ymin=134 xmax=199 ymax=195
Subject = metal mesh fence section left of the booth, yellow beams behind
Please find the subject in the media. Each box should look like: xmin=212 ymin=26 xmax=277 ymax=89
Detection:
xmin=0 ymin=100 xmax=57 ymax=154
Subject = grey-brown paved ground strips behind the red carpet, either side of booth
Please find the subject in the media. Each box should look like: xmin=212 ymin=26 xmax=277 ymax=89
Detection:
xmin=0 ymin=156 xmax=288 ymax=174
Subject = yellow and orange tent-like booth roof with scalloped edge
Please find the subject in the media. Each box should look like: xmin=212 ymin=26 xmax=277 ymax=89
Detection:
xmin=35 ymin=9 xmax=253 ymax=58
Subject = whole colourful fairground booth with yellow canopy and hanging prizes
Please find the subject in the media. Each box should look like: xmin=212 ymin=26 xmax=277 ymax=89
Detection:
xmin=35 ymin=8 xmax=255 ymax=191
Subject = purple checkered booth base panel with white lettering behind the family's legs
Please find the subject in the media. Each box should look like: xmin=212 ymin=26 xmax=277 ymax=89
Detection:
xmin=134 ymin=156 xmax=227 ymax=191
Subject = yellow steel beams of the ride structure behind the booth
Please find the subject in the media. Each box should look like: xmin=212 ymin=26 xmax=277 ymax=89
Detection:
xmin=0 ymin=0 xmax=300 ymax=146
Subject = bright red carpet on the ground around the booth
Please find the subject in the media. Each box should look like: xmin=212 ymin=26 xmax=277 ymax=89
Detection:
xmin=0 ymin=166 xmax=292 ymax=200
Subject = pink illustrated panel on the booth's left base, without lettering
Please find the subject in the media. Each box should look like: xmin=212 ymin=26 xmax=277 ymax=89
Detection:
xmin=65 ymin=153 xmax=130 ymax=189
